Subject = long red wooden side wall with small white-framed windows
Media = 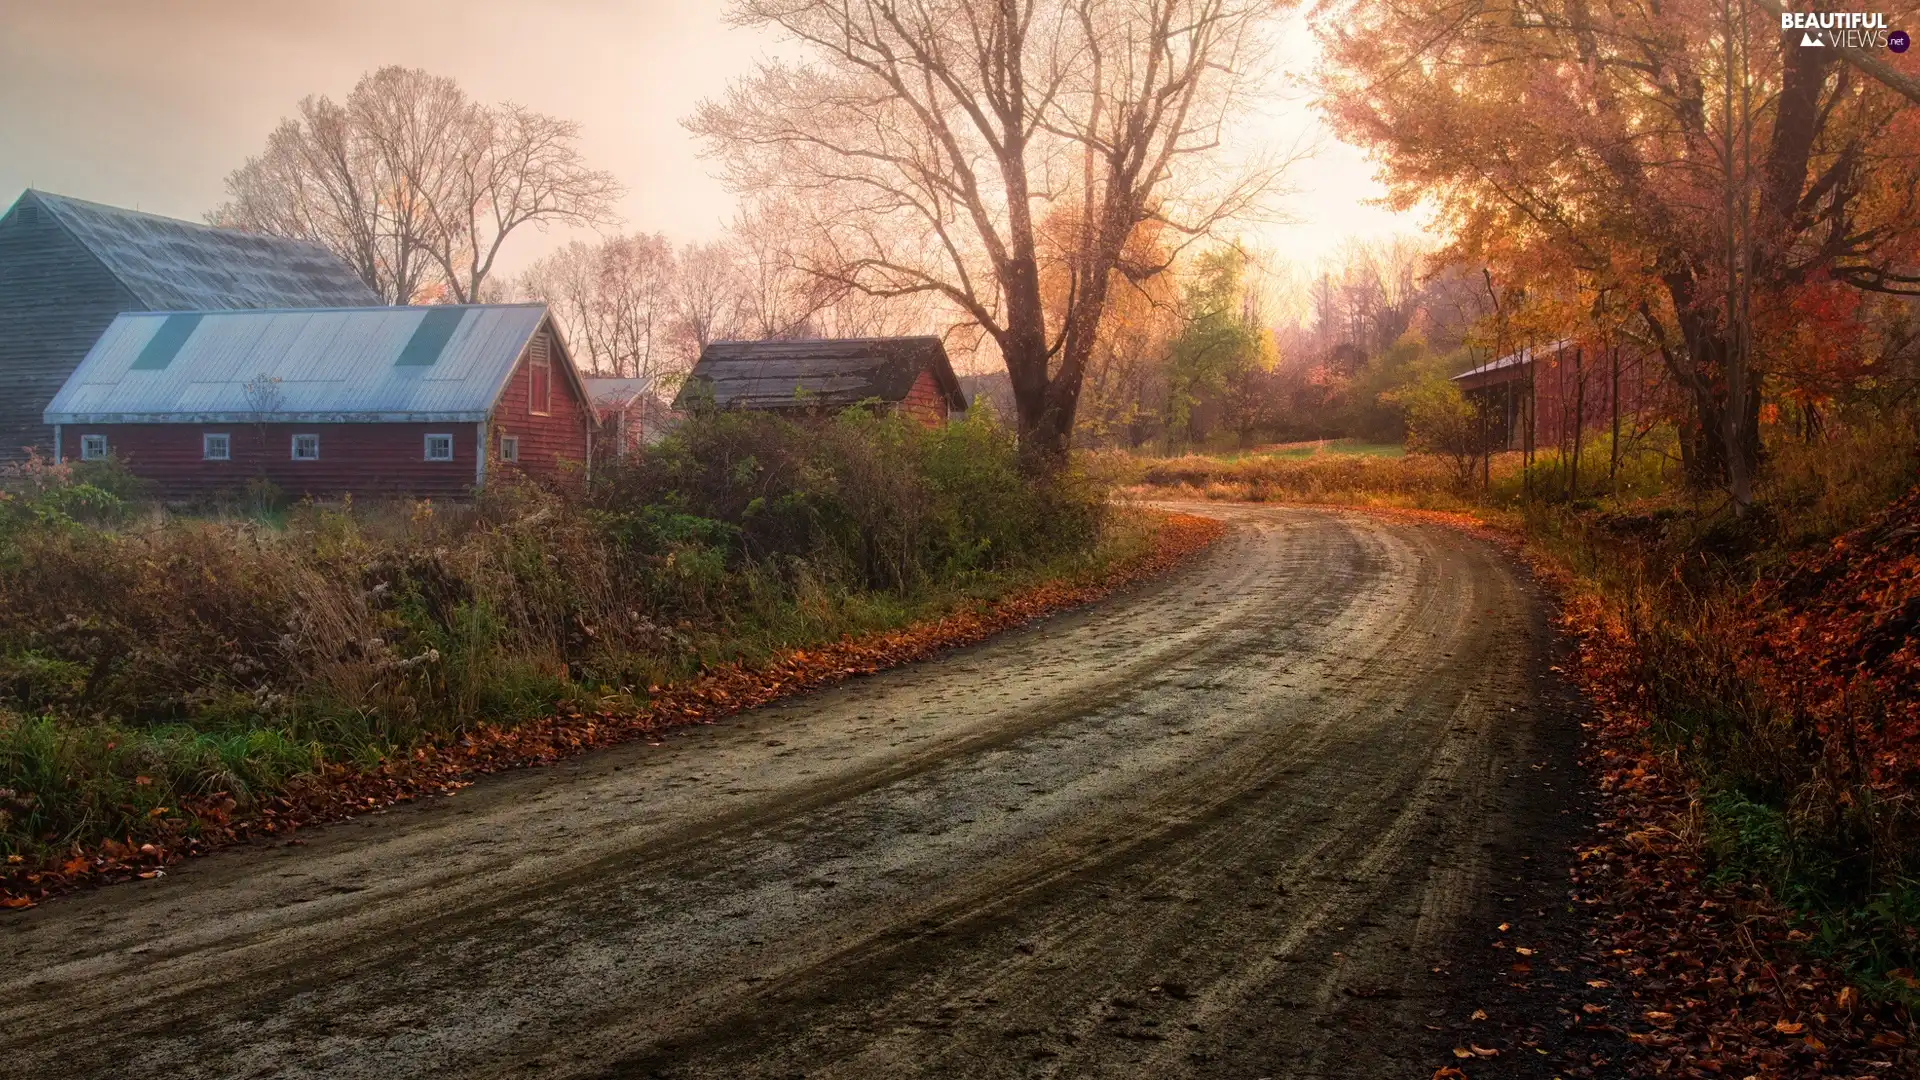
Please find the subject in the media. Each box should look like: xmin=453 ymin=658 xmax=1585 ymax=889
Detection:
xmin=60 ymin=423 xmax=480 ymax=500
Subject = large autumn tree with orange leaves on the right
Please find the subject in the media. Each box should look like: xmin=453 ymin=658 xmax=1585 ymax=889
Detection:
xmin=1323 ymin=0 xmax=1920 ymax=505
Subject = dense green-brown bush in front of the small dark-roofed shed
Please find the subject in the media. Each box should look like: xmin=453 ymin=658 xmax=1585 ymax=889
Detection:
xmin=595 ymin=409 xmax=1104 ymax=594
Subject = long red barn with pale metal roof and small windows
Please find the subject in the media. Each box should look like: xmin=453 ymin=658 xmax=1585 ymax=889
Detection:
xmin=44 ymin=304 xmax=593 ymax=500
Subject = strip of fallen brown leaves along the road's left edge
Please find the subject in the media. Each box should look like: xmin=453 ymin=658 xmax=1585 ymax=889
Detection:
xmin=0 ymin=513 xmax=1225 ymax=909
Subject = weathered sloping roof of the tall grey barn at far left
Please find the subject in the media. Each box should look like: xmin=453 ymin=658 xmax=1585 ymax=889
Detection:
xmin=21 ymin=190 xmax=380 ymax=311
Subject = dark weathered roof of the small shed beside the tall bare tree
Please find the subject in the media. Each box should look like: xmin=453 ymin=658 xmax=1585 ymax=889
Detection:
xmin=674 ymin=336 xmax=966 ymax=413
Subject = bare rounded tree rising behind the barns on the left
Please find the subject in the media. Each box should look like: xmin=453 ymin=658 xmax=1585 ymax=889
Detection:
xmin=207 ymin=67 xmax=620 ymax=304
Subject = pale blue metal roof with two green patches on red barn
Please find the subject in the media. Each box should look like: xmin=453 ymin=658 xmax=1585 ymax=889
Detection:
xmin=44 ymin=304 xmax=560 ymax=425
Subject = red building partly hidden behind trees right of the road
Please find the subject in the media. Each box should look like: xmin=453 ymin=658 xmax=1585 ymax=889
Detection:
xmin=1453 ymin=338 xmax=1665 ymax=450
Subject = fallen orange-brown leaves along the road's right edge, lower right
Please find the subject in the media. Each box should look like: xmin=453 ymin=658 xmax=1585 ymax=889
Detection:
xmin=1561 ymin=582 xmax=1920 ymax=1078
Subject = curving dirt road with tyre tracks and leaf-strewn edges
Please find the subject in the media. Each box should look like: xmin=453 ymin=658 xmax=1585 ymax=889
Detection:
xmin=0 ymin=507 xmax=1571 ymax=1080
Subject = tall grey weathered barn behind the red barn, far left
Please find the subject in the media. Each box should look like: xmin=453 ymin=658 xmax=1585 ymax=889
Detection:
xmin=0 ymin=190 xmax=380 ymax=461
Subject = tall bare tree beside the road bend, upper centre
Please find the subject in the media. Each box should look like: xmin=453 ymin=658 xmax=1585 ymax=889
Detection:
xmin=689 ymin=0 xmax=1279 ymax=457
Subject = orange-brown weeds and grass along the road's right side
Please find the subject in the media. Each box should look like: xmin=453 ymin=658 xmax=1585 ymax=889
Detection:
xmin=1100 ymin=415 xmax=1920 ymax=1007
